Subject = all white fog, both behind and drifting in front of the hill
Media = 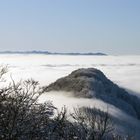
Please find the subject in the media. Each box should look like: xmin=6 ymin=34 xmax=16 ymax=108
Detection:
xmin=0 ymin=54 xmax=140 ymax=137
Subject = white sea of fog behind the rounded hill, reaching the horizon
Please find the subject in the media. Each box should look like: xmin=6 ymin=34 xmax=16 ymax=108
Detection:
xmin=0 ymin=54 xmax=140 ymax=94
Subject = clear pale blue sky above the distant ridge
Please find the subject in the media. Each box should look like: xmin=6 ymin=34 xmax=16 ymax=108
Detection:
xmin=0 ymin=0 xmax=140 ymax=54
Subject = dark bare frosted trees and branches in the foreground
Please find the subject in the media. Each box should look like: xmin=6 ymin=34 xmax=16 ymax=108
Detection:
xmin=0 ymin=67 xmax=134 ymax=140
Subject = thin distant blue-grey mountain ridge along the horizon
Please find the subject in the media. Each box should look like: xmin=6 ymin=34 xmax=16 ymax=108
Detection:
xmin=0 ymin=50 xmax=107 ymax=56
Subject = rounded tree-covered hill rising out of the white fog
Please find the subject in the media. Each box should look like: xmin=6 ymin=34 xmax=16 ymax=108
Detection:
xmin=45 ymin=68 xmax=140 ymax=119
